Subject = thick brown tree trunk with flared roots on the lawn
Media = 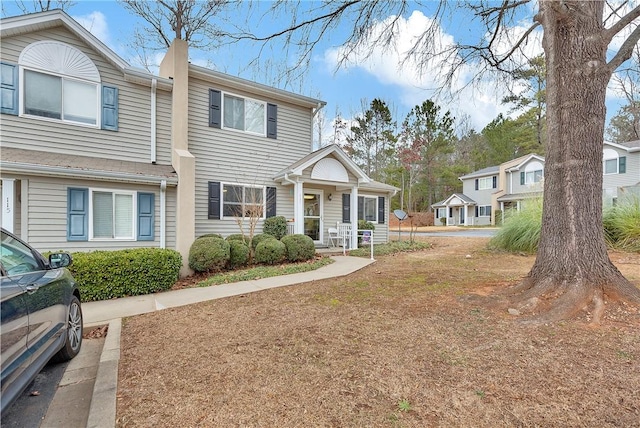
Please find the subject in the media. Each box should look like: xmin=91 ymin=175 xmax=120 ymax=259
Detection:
xmin=514 ymin=1 xmax=640 ymax=322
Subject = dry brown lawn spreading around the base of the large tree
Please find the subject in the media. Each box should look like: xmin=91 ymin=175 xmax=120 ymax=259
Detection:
xmin=117 ymin=238 xmax=640 ymax=428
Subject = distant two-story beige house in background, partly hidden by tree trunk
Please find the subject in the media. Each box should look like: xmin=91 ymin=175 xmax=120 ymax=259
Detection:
xmin=432 ymin=141 xmax=640 ymax=226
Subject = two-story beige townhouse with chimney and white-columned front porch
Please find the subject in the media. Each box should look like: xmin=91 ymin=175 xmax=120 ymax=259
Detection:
xmin=0 ymin=10 xmax=397 ymax=274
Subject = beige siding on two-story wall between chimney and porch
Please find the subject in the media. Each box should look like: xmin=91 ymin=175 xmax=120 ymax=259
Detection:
xmin=189 ymin=78 xmax=313 ymax=236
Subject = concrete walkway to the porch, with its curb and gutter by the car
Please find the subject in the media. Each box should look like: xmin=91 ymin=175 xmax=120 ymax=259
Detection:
xmin=53 ymin=256 xmax=374 ymax=428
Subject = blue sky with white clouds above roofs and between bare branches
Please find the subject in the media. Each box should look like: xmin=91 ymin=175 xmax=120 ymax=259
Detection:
xmin=3 ymin=0 xmax=636 ymax=141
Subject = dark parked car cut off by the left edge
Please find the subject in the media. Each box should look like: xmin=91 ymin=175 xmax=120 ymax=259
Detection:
xmin=0 ymin=229 xmax=82 ymax=412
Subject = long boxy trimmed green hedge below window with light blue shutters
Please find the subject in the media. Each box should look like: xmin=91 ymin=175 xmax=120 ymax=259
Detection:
xmin=69 ymin=248 xmax=182 ymax=302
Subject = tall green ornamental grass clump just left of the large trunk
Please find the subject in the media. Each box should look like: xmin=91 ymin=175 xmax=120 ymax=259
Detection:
xmin=489 ymin=198 xmax=542 ymax=253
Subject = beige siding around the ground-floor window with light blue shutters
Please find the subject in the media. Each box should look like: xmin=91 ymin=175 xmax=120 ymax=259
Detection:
xmin=14 ymin=176 xmax=175 ymax=251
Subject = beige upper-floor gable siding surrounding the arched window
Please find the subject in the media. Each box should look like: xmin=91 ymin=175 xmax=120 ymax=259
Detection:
xmin=2 ymin=27 xmax=171 ymax=163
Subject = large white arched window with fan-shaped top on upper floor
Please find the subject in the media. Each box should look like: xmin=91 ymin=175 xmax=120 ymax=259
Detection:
xmin=18 ymin=41 xmax=100 ymax=126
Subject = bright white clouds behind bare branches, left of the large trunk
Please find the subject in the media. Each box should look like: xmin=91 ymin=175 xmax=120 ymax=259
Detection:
xmin=323 ymin=11 xmax=542 ymax=129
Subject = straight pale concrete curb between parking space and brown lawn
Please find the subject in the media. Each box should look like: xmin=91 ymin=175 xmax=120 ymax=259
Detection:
xmin=87 ymin=318 xmax=122 ymax=428
